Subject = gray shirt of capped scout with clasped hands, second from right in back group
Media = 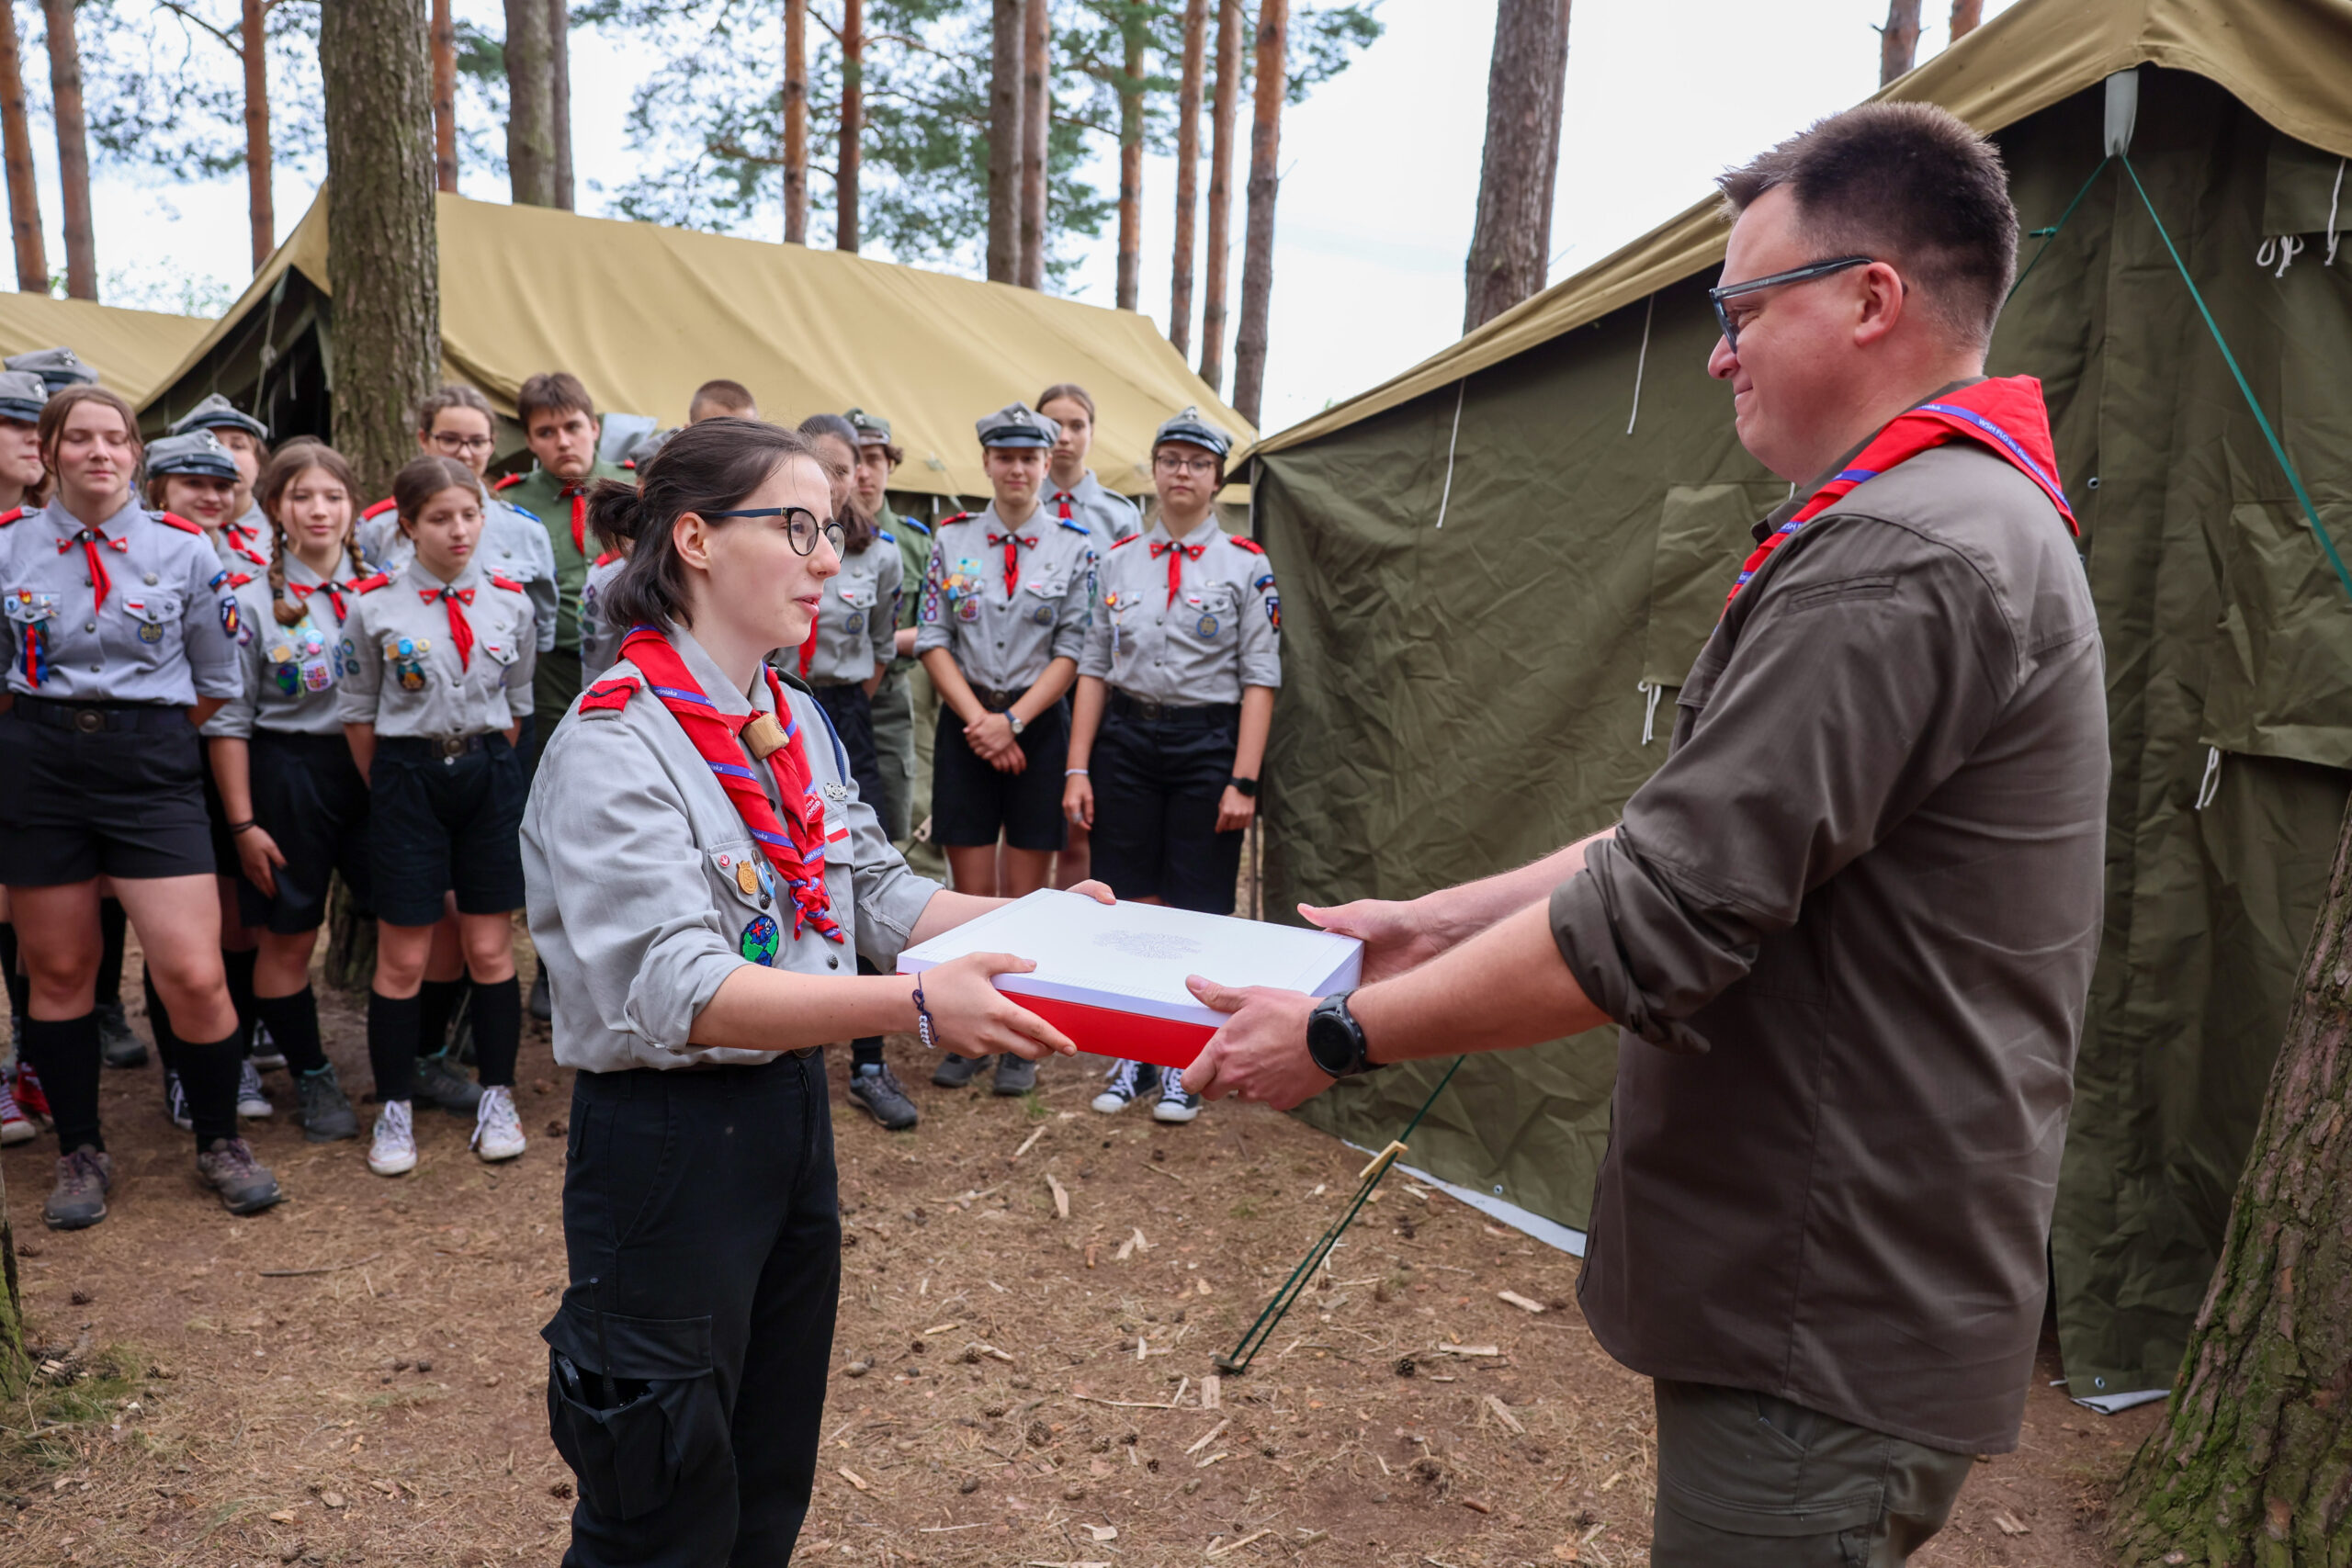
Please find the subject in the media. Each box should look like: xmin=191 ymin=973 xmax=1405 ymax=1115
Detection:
xmin=915 ymin=505 xmax=1096 ymax=691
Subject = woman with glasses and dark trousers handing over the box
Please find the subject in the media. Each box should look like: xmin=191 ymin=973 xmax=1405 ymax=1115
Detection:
xmin=522 ymin=421 xmax=1105 ymax=1568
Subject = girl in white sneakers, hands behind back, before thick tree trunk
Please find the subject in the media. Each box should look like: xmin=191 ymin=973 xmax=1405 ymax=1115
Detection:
xmin=336 ymin=456 xmax=538 ymax=1176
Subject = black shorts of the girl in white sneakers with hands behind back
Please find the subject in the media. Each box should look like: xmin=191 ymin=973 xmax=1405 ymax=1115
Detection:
xmin=367 ymin=731 xmax=526 ymax=926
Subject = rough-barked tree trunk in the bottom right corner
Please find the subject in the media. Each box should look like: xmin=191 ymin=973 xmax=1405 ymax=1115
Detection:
xmin=2112 ymin=799 xmax=2352 ymax=1568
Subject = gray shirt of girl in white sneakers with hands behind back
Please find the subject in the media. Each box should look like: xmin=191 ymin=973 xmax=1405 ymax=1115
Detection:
xmin=336 ymin=559 xmax=538 ymax=740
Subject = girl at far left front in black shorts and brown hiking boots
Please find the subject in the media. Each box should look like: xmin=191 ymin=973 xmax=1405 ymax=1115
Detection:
xmin=0 ymin=386 xmax=280 ymax=1229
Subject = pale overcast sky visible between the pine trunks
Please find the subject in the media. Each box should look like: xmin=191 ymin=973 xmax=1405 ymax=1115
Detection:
xmin=55 ymin=0 xmax=2007 ymax=430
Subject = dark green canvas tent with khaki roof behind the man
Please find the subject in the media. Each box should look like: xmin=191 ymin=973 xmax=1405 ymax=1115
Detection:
xmin=1251 ymin=0 xmax=2352 ymax=1401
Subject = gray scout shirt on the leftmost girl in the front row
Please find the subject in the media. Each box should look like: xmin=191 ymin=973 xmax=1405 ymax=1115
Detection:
xmin=0 ymin=501 xmax=240 ymax=707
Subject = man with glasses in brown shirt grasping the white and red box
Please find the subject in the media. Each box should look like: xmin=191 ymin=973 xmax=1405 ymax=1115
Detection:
xmin=1185 ymin=104 xmax=2108 ymax=1568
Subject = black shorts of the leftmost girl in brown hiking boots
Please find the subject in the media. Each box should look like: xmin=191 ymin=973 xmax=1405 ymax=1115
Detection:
xmin=0 ymin=698 xmax=214 ymax=886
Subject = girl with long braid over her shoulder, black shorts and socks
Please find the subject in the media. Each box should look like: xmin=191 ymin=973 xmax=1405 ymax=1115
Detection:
xmin=205 ymin=442 xmax=369 ymax=1143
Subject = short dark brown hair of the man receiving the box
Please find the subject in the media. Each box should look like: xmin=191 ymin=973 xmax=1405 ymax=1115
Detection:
xmin=1714 ymin=104 xmax=2018 ymax=345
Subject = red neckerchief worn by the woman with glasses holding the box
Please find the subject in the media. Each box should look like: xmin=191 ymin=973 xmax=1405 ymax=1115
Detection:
xmin=621 ymin=626 xmax=844 ymax=942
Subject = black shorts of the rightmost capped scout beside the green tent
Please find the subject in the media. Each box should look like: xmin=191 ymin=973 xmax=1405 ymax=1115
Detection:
xmin=1087 ymin=694 xmax=1244 ymax=915
